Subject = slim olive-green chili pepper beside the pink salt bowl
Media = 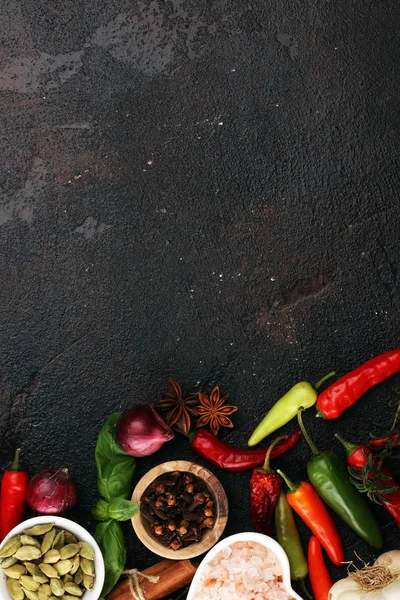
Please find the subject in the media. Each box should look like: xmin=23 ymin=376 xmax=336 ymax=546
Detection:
xmin=275 ymin=490 xmax=311 ymax=598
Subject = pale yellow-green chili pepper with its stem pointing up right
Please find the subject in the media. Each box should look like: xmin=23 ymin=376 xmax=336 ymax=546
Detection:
xmin=248 ymin=372 xmax=335 ymax=446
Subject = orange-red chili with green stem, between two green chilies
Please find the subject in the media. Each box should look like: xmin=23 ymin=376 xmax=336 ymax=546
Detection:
xmin=277 ymin=469 xmax=344 ymax=567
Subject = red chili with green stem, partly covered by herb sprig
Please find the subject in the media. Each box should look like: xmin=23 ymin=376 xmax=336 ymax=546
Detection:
xmin=335 ymin=433 xmax=400 ymax=529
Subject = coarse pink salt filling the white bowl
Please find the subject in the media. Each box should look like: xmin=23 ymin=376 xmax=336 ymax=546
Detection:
xmin=194 ymin=542 xmax=293 ymax=600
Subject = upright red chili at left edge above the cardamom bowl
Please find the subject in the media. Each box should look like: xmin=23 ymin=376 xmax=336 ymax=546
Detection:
xmin=0 ymin=448 xmax=29 ymax=541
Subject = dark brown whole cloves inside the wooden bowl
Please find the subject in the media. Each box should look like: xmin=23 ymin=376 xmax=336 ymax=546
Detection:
xmin=140 ymin=471 xmax=215 ymax=550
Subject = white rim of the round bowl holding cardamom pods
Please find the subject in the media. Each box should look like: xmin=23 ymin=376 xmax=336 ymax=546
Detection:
xmin=0 ymin=515 xmax=104 ymax=600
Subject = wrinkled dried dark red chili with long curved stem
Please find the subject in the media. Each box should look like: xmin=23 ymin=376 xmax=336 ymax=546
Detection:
xmin=250 ymin=435 xmax=287 ymax=535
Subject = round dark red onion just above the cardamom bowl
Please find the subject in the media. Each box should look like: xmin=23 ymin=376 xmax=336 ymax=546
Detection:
xmin=26 ymin=469 xmax=78 ymax=515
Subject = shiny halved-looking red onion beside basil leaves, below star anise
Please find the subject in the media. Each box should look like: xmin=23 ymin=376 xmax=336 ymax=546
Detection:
xmin=115 ymin=404 xmax=175 ymax=456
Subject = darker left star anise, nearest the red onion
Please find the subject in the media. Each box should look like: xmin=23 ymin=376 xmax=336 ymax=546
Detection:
xmin=156 ymin=377 xmax=199 ymax=435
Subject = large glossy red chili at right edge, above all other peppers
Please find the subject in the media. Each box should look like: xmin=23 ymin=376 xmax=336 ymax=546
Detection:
xmin=317 ymin=350 xmax=400 ymax=419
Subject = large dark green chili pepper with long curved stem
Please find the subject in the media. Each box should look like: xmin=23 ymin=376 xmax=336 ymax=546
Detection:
xmin=298 ymin=409 xmax=383 ymax=548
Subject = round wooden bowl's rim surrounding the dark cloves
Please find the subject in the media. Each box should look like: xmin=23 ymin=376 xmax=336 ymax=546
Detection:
xmin=132 ymin=460 xmax=228 ymax=560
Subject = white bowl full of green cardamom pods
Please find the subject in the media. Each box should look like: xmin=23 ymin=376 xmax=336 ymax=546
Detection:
xmin=0 ymin=515 xmax=105 ymax=600
